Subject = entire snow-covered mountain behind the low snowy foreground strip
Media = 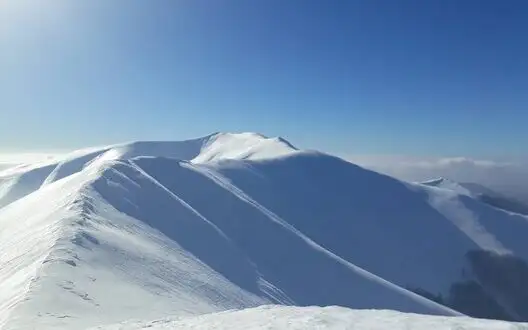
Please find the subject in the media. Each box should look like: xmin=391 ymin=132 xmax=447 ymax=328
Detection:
xmin=0 ymin=133 xmax=528 ymax=329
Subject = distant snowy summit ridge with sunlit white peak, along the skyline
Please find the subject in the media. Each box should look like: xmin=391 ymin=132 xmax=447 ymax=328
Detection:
xmin=0 ymin=133 xmax=295 ymax=207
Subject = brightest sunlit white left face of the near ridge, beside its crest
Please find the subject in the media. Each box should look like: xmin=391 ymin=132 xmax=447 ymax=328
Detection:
xmin=0 ymin=170 xmax=94 ymax=327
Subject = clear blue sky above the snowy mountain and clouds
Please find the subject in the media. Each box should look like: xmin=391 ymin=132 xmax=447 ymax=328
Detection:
xmin=0 ymin=0 xmax=528 ymax=157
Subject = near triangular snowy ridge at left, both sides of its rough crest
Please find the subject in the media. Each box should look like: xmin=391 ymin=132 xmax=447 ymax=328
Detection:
xmin=0 ymin=161 xmax=269 ymax=329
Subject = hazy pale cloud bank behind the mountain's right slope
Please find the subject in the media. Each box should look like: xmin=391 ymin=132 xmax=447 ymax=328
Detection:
xmin=345 ymin=156 xmax=528 ymax=203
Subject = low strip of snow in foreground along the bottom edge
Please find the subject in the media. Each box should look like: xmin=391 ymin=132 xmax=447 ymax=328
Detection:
xmin=92 ymin=306 xmax=528 ymax=330
